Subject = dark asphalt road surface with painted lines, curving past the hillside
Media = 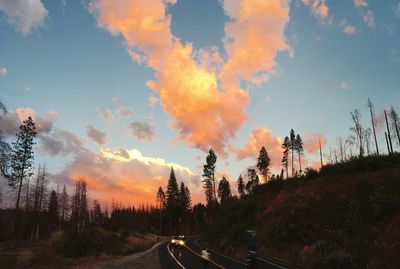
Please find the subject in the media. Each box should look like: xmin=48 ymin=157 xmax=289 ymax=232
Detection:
xmin=159 ymin=239 xmax=287 ymax=269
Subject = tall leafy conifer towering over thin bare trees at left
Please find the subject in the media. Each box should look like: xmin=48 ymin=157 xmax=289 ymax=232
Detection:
xmin=9 ymin=117 xmax=36 ymax=209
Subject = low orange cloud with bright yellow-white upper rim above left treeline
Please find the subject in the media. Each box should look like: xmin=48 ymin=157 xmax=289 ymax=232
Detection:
xmin=54 ymin=149 xmax=203 ymax=206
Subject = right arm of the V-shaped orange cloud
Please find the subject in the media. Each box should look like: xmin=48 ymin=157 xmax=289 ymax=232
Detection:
xmin=221 ymin=0 xmax=289 ymax=87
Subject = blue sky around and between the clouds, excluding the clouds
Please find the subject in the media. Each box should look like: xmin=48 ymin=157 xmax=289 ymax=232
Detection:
xmin=0 ymin=0 xmax=400 ymax=204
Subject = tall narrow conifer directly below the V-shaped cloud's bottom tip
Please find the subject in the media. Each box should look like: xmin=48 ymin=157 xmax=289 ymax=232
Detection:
xmin=202 ymin=149 xmax=217 ymax=204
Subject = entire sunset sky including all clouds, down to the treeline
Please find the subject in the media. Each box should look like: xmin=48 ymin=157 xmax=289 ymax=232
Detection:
xmin=0 ymin=0 xmax=400 ymax=205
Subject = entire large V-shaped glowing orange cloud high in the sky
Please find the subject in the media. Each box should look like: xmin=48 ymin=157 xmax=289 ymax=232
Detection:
xmin=90 ymin=0 xmax=289 ymax=155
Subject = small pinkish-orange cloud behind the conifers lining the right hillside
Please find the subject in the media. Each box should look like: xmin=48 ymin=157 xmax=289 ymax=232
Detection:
xmin=231 ymin=127 xmax=282 ymax=168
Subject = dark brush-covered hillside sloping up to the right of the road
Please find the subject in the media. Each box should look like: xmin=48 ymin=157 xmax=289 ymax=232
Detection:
xmin=208 ymin=155 xmax=400 ymax=268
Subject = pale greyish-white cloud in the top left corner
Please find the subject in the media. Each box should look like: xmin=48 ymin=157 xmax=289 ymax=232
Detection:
xmin=0 ymin=0 xmax=49 ymax=36
